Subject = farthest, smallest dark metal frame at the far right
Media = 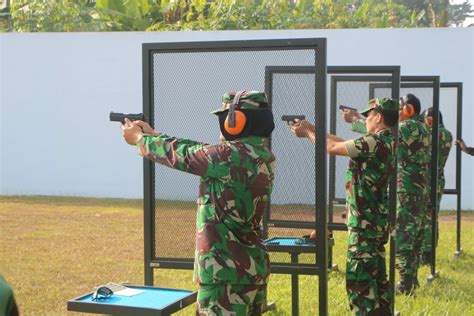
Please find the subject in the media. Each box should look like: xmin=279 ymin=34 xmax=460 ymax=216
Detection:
xmin=370 ymin=80 xmax=463 ymax=258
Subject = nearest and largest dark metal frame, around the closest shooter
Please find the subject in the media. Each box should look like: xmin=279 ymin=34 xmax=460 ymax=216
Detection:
xmin=142 ymin=38 xmax=328 ymax=315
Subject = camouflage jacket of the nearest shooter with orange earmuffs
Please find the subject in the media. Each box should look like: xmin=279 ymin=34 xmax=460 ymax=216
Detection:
xmin=137 ymin=134 xmax=275 ymax=284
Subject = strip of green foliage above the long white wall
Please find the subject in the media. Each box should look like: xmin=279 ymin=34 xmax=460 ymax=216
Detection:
xmin=0 ymin=0 xmax=473 ymax=32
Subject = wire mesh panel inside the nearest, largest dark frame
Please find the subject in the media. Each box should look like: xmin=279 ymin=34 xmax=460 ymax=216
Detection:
xmin=152 ymin=49 xmax=316 ymax=259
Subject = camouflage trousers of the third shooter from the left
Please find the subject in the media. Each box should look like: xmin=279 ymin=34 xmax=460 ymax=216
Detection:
xmin=395 ymin=193 xmax=427 ymax=278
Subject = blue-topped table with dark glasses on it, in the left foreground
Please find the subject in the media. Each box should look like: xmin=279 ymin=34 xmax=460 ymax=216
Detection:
xmin=67 ymin=285 xmax=197 ymax=315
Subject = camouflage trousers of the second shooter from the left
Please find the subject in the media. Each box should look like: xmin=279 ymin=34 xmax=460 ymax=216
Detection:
xmin=346 ymin=227 xmax=391 ymax=315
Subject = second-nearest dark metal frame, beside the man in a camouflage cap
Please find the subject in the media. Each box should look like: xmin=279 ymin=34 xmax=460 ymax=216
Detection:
xmin=265 ymin=66 xmax=400 ymax=315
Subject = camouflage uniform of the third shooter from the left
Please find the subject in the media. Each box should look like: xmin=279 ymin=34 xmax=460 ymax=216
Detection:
xmin=395 ymin=115 xmax=431 ymax=291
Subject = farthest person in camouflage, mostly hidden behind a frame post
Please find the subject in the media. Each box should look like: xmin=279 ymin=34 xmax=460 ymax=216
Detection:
xmin=421 ymin=108 xmax=453 ymax=264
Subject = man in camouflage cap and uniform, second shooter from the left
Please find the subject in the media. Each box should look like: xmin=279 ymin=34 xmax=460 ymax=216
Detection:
xmin=291 ymin=98 xmax=398 ymax=315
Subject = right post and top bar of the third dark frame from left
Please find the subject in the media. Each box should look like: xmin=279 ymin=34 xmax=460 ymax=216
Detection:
xmin=371 ymin=76 xmax=440 ymax=284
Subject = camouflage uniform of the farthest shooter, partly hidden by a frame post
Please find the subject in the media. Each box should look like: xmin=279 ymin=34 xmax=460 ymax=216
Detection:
xmin=421 ymin=125 xmax=453 ymax=254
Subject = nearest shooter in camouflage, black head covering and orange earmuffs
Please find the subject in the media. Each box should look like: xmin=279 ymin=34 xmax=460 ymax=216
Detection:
xmin=124 ymin=91 xmax=275 ymax=315
